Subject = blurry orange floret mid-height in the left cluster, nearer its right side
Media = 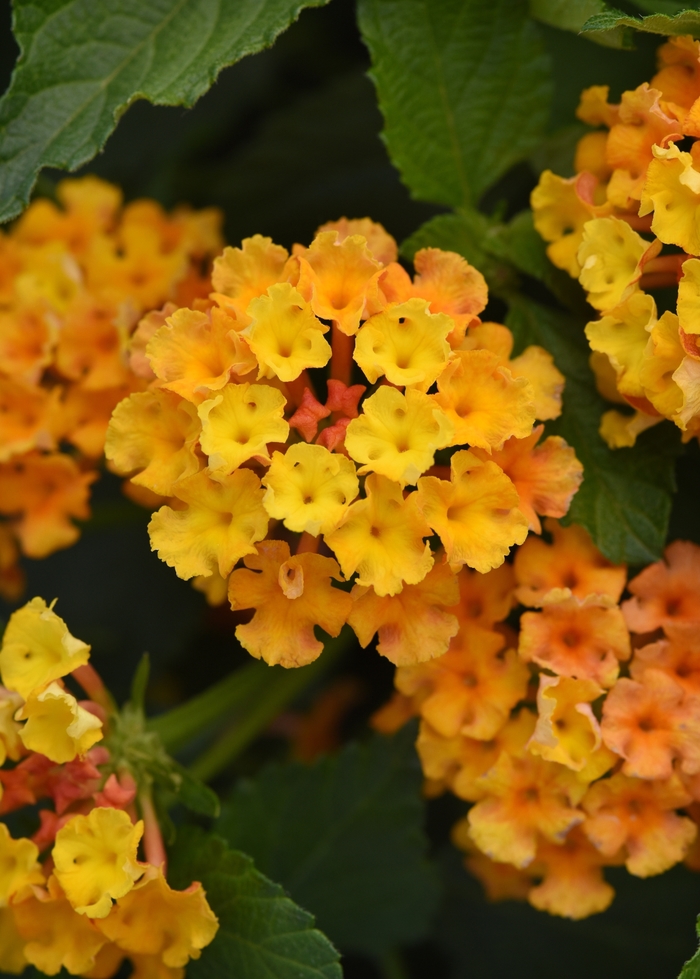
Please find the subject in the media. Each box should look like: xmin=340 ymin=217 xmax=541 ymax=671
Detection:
xmin=56 ymin=296 xmax=130 ymax=391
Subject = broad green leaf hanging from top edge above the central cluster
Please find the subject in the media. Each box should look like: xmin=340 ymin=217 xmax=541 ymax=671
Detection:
xmin=358 ymin=0 xmax=551 ymax=207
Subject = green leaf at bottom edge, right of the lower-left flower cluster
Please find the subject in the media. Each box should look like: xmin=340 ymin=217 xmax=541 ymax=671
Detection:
xmin=168 ymin=827 xmax=342 ymax=979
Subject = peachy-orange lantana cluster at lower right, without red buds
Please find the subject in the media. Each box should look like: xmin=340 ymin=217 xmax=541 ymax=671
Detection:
xmin=374 ymin=521 xmax=700 ymax=918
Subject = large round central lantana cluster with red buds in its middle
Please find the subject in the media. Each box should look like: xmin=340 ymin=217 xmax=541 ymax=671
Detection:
xmin=106 ymin=219 xmax=582 ymax=666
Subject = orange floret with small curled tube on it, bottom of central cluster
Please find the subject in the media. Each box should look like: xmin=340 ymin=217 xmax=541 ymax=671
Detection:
xmin=229 ymin=540 xmax=352 ymax=667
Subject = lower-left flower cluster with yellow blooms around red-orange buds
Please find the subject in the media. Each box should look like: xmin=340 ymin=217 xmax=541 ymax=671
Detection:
xmin=0 ymin=598 xmax=218 ymax=979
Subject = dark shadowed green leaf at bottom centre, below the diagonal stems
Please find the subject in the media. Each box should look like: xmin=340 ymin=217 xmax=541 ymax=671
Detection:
xmin=217 ymin=725 xmax=438 ymax=954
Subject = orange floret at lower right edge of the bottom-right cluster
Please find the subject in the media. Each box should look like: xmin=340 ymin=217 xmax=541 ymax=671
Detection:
xmin=582 ymin=773 xmax=697 ymax=877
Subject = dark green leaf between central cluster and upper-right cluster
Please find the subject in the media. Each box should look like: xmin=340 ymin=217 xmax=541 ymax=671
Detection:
xmin=506 ymin=296 xmax=680 ymax=564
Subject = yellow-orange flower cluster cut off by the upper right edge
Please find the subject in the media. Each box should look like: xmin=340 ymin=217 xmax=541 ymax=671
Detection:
xmin=531 ymin=37 xmax=700 ymax=448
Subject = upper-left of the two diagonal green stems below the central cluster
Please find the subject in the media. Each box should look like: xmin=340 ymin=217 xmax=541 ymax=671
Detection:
xmin=148 ymin=663 xmax=270 ymax=752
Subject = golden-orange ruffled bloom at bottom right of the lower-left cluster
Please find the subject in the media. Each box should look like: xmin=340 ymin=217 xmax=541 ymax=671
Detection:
xmin=98 ymin=867 xmax=219 ymax=969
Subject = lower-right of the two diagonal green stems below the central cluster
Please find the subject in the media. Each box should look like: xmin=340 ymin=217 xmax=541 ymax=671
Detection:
xmin=190 ymin=626 xmax=354 ymax=782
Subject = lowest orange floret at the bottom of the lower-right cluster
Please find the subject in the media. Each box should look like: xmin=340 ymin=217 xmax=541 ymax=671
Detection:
xmin=527 ymin=826 xmax=615 ymax=921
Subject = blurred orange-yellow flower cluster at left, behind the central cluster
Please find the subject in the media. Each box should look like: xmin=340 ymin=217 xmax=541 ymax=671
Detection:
xmin=0 ymin=177 xmax=221 ymax=599
